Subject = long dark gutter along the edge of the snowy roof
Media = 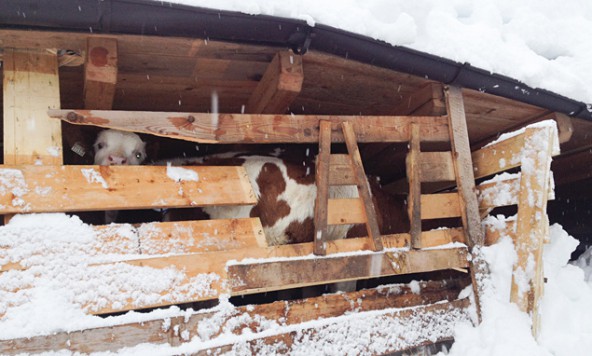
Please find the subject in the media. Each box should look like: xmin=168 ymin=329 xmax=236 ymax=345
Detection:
xmin=0 ymin=0 xmax=592 ymax=120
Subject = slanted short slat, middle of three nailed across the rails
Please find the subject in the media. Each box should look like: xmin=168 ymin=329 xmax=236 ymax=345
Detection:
xmin=342 ymin=122 xmax=384 ymax=251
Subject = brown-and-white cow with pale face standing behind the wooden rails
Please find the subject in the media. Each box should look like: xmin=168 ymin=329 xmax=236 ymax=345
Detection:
xmin=95 ymin=130 xmax=409 ymax=246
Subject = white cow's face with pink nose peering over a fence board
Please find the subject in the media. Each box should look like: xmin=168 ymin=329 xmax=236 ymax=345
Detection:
xmin=93 ymin=130 xmax=146 ymax=166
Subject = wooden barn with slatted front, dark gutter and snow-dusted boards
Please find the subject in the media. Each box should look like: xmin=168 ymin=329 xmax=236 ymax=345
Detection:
xmin=0 ymin=0 xmax=592 ymax=355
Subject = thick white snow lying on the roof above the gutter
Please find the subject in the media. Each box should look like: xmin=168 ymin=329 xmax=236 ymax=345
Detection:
xmin=156 ymin=0 xmax=592 ymax=105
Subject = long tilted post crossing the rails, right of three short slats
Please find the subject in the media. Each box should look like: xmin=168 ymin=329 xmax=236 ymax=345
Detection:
xmin=445 ymin=87 xmax=488 ymax=322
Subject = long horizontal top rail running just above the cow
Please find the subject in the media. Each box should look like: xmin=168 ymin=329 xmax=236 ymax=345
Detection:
xmin=49 ymin=110 xmax=449 ymax=143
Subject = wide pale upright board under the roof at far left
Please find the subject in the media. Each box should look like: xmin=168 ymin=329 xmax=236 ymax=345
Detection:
xmin=2 ymin=48 xmax=62 ymax=165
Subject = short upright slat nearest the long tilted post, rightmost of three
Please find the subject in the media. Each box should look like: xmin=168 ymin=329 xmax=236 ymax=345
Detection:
xmin=405 ymin=123 xmax=422 ymax=248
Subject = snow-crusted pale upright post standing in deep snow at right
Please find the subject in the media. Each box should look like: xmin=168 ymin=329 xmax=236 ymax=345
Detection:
xmin=510 ymin=127 xmax=555 ymax=337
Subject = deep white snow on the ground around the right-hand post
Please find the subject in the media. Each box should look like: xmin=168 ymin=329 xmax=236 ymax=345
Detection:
xmin=447 ymin=222 xmax=592 ymax=356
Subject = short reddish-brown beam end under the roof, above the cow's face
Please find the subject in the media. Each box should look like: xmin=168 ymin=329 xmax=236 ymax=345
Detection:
xmin=84 ymin=37 xmax=118 ymax=110
